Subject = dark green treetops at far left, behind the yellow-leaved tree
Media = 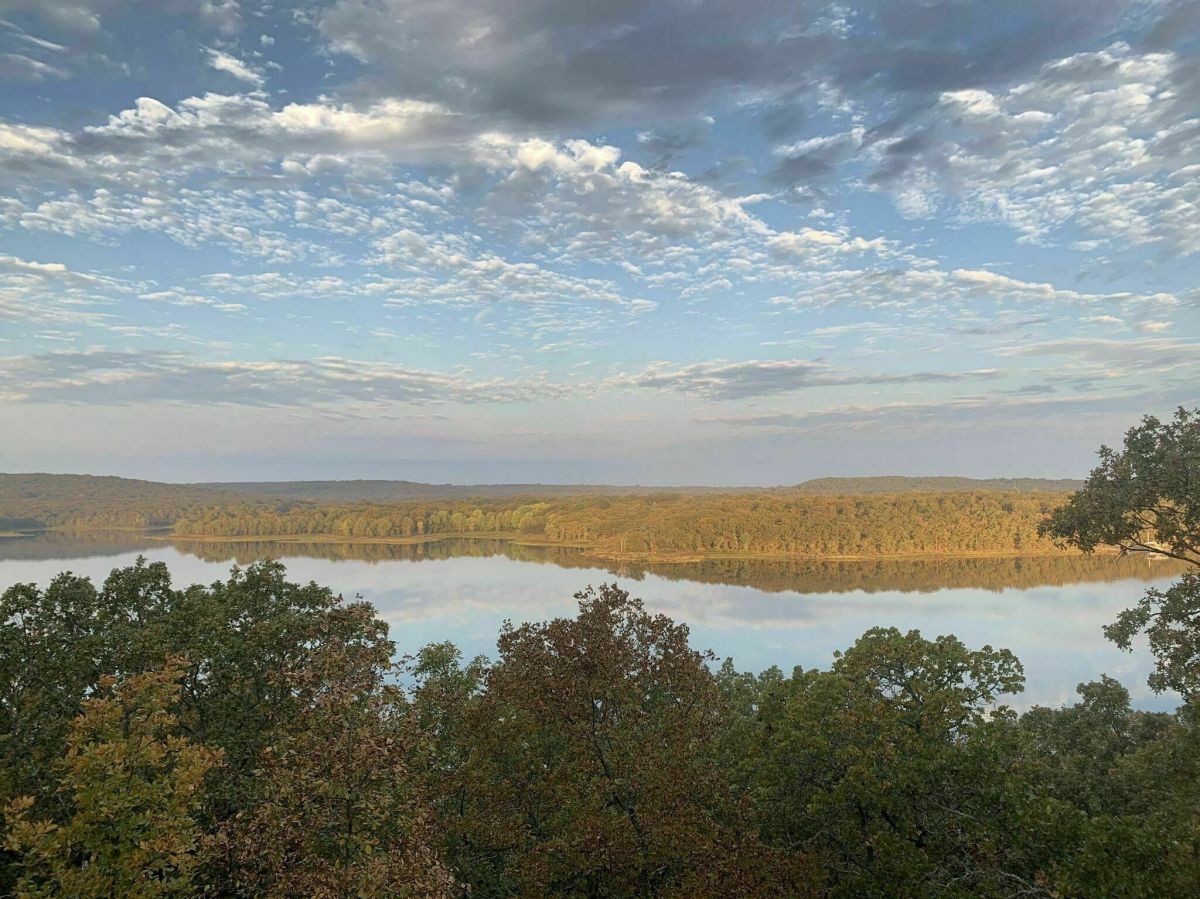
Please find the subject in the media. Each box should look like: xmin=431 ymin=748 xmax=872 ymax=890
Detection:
xmin=0 ymin=559 xmax=403 ymax=894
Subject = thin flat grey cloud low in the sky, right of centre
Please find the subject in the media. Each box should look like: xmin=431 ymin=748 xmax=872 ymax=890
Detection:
xmin=606 ymin=359 xmax=1001 ymax=400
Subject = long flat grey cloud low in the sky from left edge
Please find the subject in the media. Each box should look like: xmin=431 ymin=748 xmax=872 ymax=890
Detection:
xmin=0 ymin=350 xmax=557 ymax=406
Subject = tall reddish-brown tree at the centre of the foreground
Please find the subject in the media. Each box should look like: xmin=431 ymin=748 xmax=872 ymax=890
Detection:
xmin=449 ymin=585 xmax=806 ymax=897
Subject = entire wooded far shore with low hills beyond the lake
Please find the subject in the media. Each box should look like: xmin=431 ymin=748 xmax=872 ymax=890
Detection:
xmin=0 ymin=474 xmax=1084 ymax=558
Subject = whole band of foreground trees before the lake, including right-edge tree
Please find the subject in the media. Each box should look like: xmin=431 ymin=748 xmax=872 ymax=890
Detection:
xmin=0 ymin=410 xmax=1200 ymax=899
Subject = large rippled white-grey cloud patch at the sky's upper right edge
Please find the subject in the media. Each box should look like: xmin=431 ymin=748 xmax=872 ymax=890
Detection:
xmin=864 ymin=43 xmax=1200 ymax=254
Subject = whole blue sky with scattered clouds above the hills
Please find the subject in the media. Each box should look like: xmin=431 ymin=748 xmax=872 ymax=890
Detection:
xmin=0 ymin=0 xmax=1200 ymax=485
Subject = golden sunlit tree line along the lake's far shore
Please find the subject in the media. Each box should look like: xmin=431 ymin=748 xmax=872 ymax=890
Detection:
xmin=164 ymin=492 xmax=1064 ymax=557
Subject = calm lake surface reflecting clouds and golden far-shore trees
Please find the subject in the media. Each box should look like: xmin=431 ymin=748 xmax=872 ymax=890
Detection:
xmin=0 ymin=534 xmax=1178 ymax=708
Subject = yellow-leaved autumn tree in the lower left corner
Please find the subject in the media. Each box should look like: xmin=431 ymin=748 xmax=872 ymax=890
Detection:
xmin=6 ymin=658 xmax=221 ymax=899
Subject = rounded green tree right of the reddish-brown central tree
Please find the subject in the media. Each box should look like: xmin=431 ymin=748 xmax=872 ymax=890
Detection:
xmin=745 ymin=628 xmax=1024 ymax=897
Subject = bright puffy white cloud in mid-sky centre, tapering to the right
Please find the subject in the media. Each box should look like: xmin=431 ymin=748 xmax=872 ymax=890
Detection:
xmin=474 ymin=133 xmax=900 ymax=280
